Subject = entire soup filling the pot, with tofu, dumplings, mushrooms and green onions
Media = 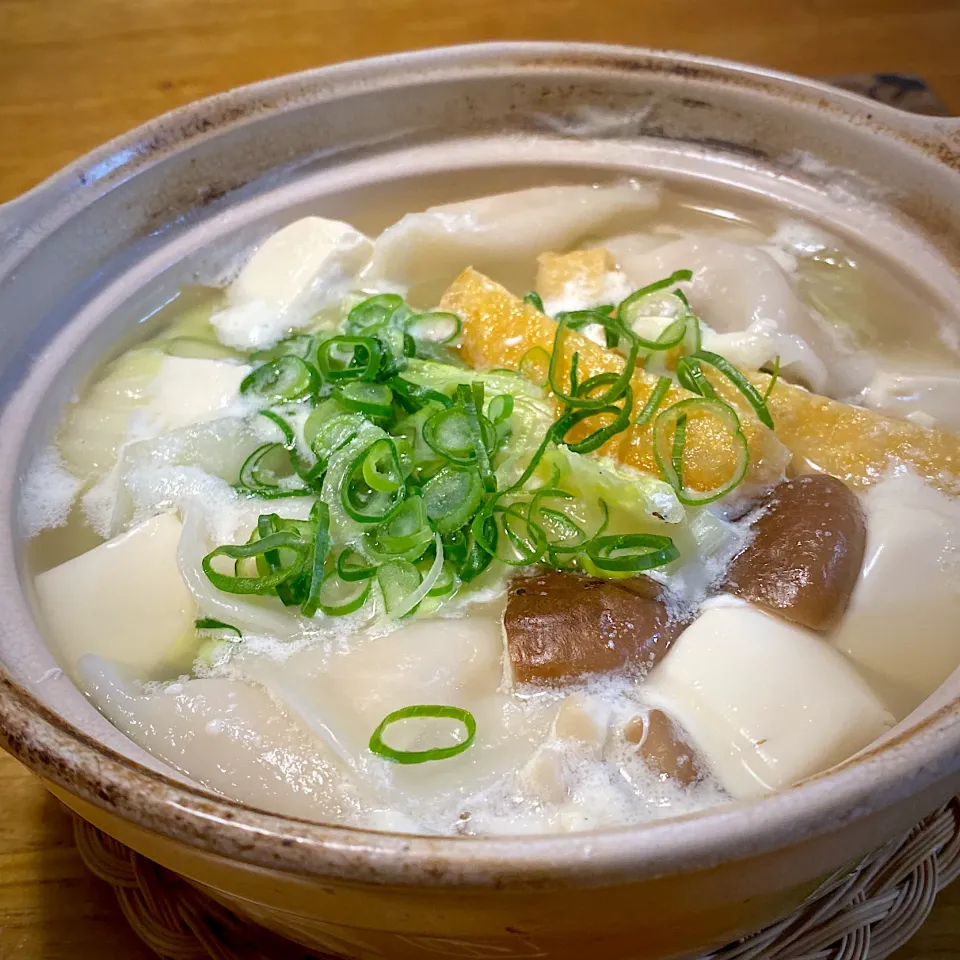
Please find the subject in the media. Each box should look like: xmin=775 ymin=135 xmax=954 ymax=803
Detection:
xmin=22 ymin=182 xmax=960 ymax=834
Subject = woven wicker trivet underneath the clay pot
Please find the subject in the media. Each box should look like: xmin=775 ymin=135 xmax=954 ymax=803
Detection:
xmin=74 ymin=797 xmax=960 ymax=960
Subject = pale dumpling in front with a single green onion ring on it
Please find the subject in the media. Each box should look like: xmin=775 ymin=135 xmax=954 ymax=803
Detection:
xmin=236 ymin=617 xmax=553 ymax=809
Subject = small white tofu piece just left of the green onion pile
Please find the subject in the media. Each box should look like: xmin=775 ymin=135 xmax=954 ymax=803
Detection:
xmin=144 ymin=357 xmax=250 ymax=436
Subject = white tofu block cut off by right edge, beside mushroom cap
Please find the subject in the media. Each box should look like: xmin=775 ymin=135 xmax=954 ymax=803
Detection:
xmin=832 ymin=473 xmax=960 ymax=719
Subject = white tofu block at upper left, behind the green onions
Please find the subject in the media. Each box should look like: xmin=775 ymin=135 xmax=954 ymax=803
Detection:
xmin=211 ymin=217 xmax=373 ymax=350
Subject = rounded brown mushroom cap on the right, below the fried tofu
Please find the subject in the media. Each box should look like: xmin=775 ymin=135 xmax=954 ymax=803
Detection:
xmin=726 ymin=474 xmax=867 ymax=630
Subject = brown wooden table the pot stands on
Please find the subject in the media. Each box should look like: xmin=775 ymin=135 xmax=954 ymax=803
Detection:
xmin=0 ymin=0 xmax=960 ymax=960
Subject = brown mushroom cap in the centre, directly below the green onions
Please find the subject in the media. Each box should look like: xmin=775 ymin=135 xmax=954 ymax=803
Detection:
xmin=503 ymin=571 xmax=683 ymax=685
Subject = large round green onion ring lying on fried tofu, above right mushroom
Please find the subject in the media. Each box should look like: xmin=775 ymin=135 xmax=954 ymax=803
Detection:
xmin=653 ymin=397 xmax=750 ymax=506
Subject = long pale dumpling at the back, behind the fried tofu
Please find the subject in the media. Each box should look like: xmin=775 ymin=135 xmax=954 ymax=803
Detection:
xmin=370 ymin=183 xmax=660 ymax=303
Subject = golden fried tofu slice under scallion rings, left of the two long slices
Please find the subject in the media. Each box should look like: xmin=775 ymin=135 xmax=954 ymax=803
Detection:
xmin=440 ymin=270 xmax=790 ymax=492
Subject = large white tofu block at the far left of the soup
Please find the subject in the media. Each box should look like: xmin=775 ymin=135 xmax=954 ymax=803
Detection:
xmin=35 ymin=514 xmax=197 ymax=680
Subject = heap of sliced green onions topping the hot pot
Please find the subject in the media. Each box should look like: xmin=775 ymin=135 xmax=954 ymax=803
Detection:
xmin=204 ymin=270 xmax=776 ymax=628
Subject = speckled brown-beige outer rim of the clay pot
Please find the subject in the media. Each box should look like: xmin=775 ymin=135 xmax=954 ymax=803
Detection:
xmin=0 ymin=43 xmax=960 ymax=888
